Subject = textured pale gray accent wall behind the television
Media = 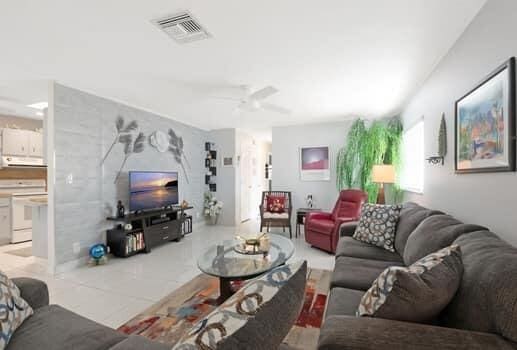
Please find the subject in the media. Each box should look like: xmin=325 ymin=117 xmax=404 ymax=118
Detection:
xmin=54 ymin=84 xmax=207 ymax=265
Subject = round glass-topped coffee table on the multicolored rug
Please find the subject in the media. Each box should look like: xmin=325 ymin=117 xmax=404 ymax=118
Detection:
xmin=197 ymin=234 xmax=294 ymax=303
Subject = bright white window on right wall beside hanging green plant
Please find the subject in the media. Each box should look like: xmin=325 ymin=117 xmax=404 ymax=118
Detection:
xmin=400 ymin=118 xmax=425 ymax=193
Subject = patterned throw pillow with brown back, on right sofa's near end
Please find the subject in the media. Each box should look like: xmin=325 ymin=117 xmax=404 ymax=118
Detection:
xmin=356 ymin=245 xmax=463 ymax=322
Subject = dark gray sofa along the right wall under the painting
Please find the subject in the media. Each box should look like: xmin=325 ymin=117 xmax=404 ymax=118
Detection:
xmin=318 ymin=203 xmax=517 ymax=350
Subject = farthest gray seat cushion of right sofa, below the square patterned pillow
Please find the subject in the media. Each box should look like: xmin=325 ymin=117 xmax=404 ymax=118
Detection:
xmin=336 ymin=237 xmax=402 ymax=262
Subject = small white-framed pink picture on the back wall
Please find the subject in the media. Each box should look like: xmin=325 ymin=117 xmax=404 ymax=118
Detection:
xmin=300 ymin=146 xmax=330 ymax=181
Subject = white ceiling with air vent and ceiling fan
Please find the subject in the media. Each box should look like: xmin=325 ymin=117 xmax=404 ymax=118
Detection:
xmin=0 ymin=0 xmax=486 ymax=129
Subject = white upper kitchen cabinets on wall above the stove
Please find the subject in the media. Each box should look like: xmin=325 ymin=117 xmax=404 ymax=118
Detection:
xmin=2 ymin=129 xmax=43 ymax=158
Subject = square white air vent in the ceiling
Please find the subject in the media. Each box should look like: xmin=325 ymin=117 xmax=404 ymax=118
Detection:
xmin=152 ymin=12 xmax=210 ymax=44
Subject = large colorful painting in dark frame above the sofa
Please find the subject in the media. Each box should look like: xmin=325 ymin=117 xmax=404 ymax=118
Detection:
xmin=455 ymin=57 xmax=515 ymax=173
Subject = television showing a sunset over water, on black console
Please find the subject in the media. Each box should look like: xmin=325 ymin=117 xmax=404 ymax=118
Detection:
xmin=129 ymin=171 xmax=178 ymax=211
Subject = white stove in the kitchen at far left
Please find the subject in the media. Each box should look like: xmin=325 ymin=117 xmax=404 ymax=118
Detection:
xmin=0 ymin=180 xmax=47 ymax=243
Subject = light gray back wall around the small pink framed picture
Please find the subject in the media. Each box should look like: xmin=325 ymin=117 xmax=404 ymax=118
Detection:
xmin=272 ymin=121 xmax=352 ymax=216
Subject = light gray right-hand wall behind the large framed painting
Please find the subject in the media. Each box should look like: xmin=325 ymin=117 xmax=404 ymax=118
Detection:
xmin=402 ymin=0 xmax=517 ymax=244
